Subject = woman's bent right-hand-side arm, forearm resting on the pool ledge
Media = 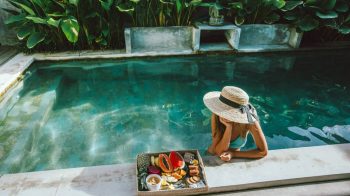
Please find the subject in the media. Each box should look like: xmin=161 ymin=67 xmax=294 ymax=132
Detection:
xmin=230 ymin=121 xmax=268 ymax=158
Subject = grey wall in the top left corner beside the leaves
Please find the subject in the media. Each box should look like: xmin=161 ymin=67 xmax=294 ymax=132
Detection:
xmin=0 ymin=0 xmax=17 ymax=45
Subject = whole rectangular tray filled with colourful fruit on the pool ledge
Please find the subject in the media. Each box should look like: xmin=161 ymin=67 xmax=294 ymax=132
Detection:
xmin=136 ymin=150 xmax=208 ymax=195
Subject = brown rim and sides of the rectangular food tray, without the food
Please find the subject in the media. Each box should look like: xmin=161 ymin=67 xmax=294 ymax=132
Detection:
xmin=136 ymin=150 xmax=208 ymax=196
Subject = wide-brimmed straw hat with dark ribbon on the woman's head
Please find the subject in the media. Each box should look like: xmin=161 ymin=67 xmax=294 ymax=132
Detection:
xmin=203 ymin=86 xmax=259 ymax=124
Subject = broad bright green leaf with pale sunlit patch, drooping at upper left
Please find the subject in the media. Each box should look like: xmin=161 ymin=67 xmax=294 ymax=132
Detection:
xmin=60 ymin=16 xmax=79 ymax=43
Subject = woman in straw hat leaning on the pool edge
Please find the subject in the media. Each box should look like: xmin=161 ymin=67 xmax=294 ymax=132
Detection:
xmin=203 ymin=86 xmax=268 ymax=161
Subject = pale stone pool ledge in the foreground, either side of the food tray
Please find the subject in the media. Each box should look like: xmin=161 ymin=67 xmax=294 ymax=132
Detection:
xmin=0 ymin=144 xmax=350 ymax=196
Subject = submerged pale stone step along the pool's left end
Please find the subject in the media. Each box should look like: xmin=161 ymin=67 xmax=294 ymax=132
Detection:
xmin=0 ymin=76 xmax=61 ymax=173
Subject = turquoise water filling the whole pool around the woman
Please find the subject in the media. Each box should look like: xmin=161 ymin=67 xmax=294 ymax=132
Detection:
xmin=0 ymin=51 xmax=350 ymax=173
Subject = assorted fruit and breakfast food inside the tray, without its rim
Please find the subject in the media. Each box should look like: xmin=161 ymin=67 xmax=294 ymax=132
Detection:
xmin=137 ymin=151 xmax=205 ymax=191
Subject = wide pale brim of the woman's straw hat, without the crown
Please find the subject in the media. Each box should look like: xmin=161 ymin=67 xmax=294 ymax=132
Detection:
xmin=203 ymin=91 xmax=257 ymax=124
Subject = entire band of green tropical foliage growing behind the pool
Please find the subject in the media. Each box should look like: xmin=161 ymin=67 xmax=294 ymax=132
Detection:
xmin=4 ymin=0 xmax=350 ymax=51
